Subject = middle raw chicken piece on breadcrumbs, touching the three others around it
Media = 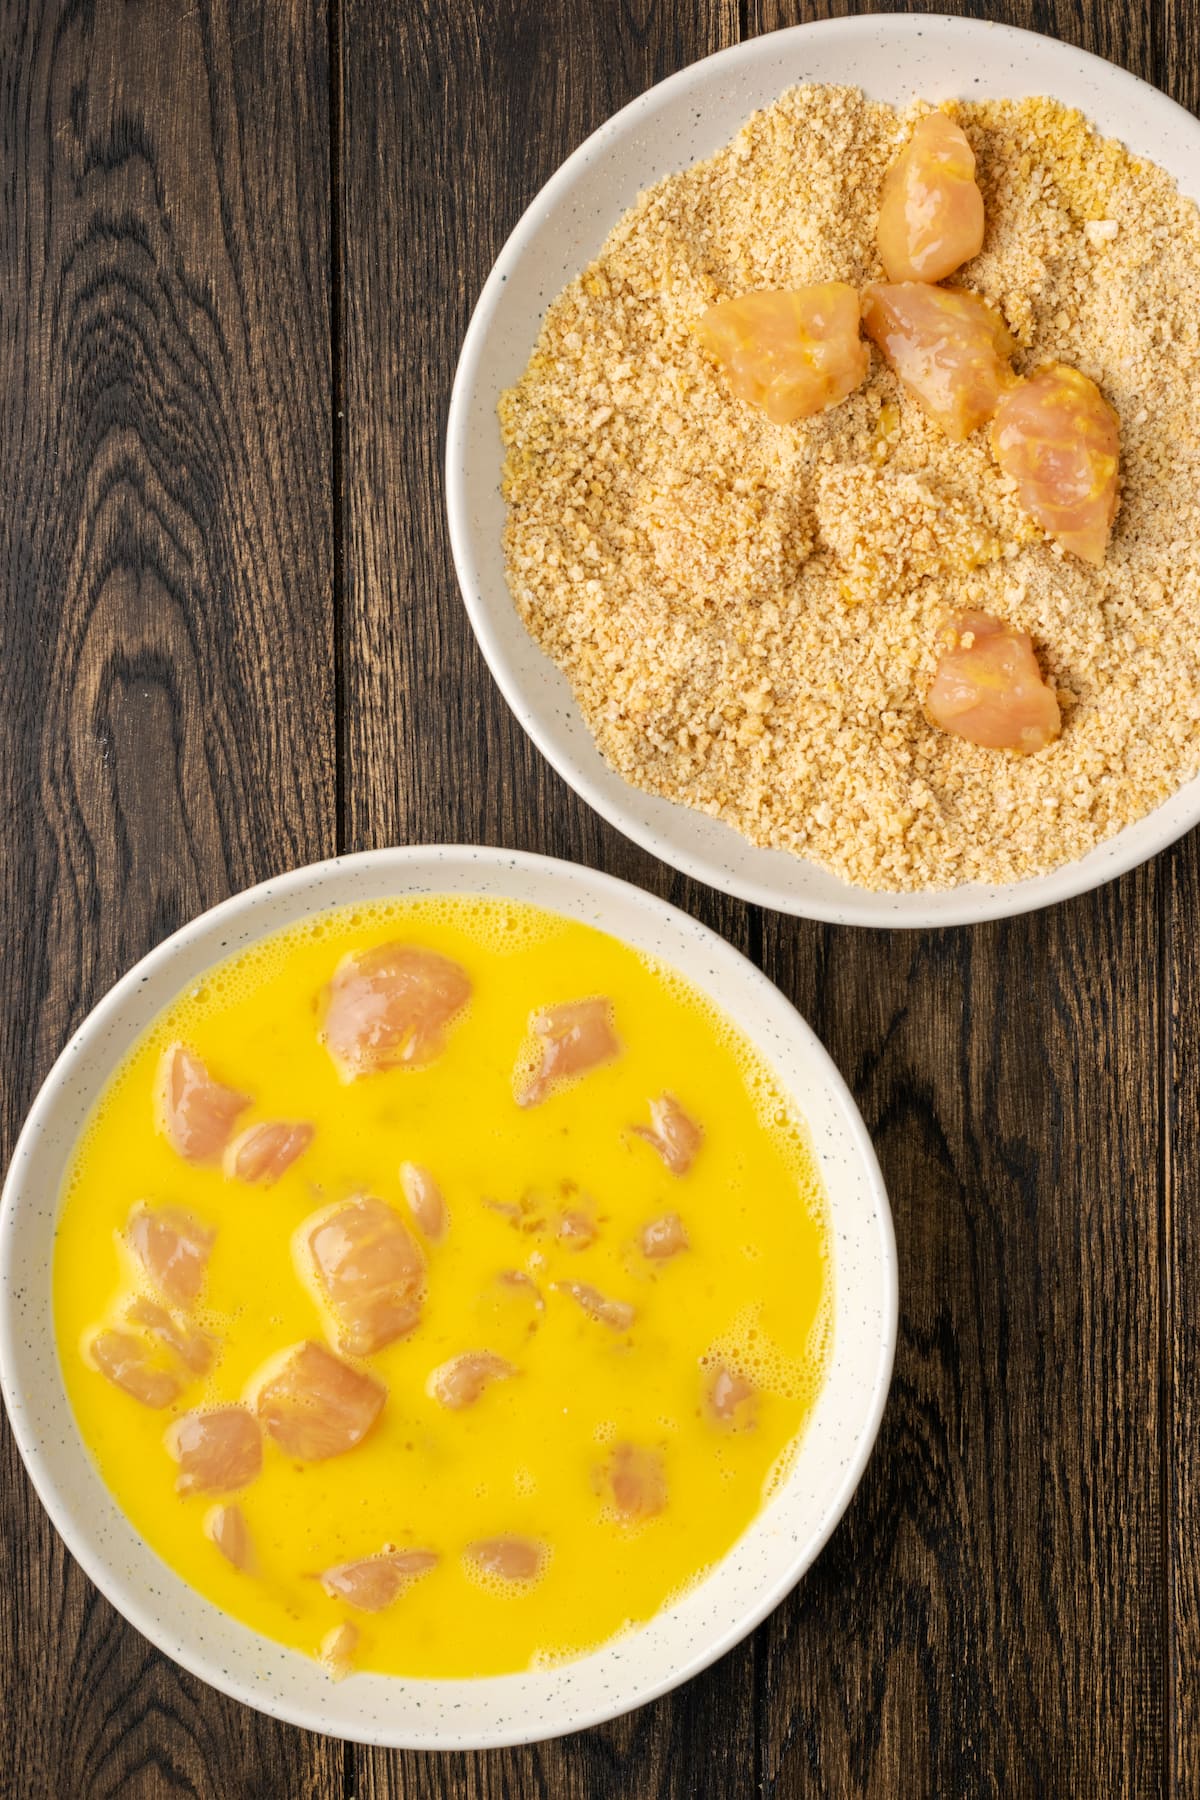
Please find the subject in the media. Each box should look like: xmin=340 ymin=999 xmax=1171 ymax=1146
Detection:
xmin=862 ymin=281 xmax=1015 ymax=443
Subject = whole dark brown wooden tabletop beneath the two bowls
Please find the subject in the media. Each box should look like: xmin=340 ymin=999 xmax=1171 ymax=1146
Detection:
xmin=0 ymin=0 xmax=1200 ymax=1800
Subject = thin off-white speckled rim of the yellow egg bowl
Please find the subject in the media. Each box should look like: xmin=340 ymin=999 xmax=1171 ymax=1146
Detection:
xmin=0 ymin=844 xmax=900 ymax=1750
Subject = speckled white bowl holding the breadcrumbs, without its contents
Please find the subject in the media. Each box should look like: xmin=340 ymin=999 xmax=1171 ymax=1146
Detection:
xmin=446 ymin=14 xmax=1200 ymax=927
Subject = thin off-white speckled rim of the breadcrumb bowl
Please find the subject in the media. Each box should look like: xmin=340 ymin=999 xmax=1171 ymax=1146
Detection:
xmin=443 ymin=13 xmax=1200 ymax=931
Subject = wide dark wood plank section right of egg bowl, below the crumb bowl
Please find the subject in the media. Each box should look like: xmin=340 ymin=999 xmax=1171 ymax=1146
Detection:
xmin=763 ymin=889 xmax=1166 ymax=1796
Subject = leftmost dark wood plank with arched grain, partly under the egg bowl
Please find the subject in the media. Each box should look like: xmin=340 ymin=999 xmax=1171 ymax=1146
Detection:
xmin=0 ymin=0 xmax=344 ymax=1800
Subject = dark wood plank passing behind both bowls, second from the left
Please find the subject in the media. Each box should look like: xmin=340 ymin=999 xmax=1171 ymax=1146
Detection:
xmin=340 ymin=0 xmax=770 ymax=1800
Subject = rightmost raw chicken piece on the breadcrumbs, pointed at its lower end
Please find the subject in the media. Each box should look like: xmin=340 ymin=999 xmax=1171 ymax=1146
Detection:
xmin=991 ymin=362 xmax=1121 ymax=569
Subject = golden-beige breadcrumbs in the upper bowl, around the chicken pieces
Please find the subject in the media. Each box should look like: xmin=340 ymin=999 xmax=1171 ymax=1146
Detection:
xmin=500 ymin=86 xmax=1200 ymax=889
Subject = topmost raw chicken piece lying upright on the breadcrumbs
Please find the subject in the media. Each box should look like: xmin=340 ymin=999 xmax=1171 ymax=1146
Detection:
xmin=878 ymin=112 xmax=984 ymax=281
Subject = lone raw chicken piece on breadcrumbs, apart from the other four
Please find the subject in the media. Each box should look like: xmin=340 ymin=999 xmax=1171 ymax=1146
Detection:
xmin=925 ymin=612 xmax=1061 ymax=756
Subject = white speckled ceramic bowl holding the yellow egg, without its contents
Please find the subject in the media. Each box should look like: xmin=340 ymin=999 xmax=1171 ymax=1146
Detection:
xmin=0 ymin=848 xmax=896 ymax=1750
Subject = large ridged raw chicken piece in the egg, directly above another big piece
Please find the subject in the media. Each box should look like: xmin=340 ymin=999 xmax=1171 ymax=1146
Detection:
xmin=300 ymin=1193 xmax=425 ymax=1355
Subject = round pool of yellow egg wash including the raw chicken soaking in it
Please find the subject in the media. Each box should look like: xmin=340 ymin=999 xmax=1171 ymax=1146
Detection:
xmin=54 ymin=898 xmax=833 ymax=1676
